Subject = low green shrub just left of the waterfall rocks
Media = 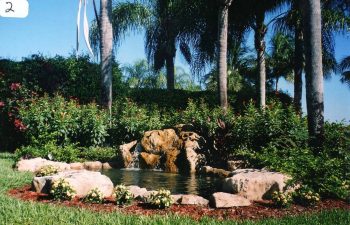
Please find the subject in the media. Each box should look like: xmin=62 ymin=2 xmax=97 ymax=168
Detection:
xmin=80 ymin=147 xmax=117 ymax=162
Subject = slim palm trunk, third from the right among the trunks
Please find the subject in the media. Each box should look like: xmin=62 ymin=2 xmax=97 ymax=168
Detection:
xmin=255 ymin=12 xmax=267 ymax=108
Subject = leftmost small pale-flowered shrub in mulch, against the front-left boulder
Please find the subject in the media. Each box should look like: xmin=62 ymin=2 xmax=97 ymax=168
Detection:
xmin=50 ymin=178 xmax=76 ymax=201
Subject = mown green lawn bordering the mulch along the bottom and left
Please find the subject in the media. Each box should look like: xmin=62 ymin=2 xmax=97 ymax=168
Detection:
xmin=0 ymin=153 xmax=350 ymax=225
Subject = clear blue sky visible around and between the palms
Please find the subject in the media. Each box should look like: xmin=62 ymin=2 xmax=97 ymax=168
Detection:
xmin=0 ymin=0 xmax=350 ymax=123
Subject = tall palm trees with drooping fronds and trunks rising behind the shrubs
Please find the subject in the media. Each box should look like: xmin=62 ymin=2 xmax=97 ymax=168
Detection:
xmin=90 ymin=0 xmax=350 ymax=147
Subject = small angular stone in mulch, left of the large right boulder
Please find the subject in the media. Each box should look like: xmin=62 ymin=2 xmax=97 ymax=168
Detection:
xmin=209 ymin=192 xmax=251 ymax=208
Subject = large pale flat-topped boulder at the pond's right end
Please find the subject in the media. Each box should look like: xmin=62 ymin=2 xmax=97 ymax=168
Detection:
xmin=223 ymin=169 xmax=291 ymax=200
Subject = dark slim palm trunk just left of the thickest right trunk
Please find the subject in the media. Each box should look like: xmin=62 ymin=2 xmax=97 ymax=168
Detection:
xmin=292 ymin=0 xmax=304 ymax=115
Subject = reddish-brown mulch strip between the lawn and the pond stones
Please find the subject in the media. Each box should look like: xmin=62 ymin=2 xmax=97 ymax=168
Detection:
xmin=8 ymin=185 xmax=350 ymax=220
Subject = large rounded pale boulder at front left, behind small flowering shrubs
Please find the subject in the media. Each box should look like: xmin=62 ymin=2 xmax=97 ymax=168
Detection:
xmin=32 ymin=170 xmax=114 ymax=197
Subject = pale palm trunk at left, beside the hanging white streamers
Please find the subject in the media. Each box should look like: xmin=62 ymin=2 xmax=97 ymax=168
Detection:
xmin=100 ymin=0 xmax=113 ymax=114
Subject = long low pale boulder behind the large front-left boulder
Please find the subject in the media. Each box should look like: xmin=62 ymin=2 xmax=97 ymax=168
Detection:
xmin=16 ymin=158 xmax=70 ymax=173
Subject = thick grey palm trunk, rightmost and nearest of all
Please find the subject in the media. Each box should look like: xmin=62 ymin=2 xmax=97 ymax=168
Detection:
xmin=303 ymin=0 xmax=324 ymax=149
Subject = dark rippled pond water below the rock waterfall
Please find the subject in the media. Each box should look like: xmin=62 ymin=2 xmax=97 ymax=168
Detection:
xmin=102 ymin=169 xmax=222 ymax=197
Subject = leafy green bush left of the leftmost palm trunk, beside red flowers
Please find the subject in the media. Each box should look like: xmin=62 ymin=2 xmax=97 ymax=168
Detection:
xmin=19 ymin=95 xmax=108 ymax=146
